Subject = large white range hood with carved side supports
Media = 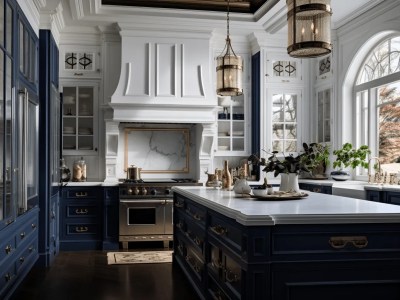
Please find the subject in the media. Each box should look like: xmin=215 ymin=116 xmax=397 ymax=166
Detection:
xmin=106 ymin=24 xmax=217 ymax=182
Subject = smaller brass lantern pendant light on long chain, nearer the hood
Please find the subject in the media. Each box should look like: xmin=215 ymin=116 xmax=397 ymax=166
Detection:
xmin=216 ymin=0 xmax=243 ymax=96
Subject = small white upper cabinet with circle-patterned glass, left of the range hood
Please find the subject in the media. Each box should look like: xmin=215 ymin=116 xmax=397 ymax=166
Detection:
xmin=59 ymin=45 xmax=101 ymax=78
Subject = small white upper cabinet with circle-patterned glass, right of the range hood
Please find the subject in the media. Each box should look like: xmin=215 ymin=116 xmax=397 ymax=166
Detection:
xmin=265 ymin=52 xmax=303 ymax=83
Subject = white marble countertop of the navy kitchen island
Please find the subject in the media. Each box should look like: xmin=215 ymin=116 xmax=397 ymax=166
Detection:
xmin=173 ymin=186 xmax=400 ymax=226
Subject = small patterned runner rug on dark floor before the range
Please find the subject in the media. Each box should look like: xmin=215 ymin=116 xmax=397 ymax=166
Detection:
xmin=107 ymin=251 xmax=173 ymax=265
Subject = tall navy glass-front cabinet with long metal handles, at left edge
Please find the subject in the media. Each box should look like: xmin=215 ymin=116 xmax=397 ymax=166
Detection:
xmin=0 ymin=1 xmax=39 ymax=225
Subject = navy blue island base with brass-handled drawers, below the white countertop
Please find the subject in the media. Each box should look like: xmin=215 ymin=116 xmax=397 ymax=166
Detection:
xmin=174 ymin=193 xmax=400 ymax=300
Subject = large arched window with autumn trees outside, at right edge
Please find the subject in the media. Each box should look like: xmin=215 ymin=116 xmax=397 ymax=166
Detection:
xmin=354 ymin=36 xmax=400 ymax=174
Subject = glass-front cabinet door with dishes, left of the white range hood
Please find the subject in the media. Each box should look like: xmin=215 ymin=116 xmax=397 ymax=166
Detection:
xmin=62 ymin=82 xmax=99 ymax=155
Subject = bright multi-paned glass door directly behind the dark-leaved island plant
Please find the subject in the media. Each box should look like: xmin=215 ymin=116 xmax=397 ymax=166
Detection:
xmin=272 ymin=93 xmax=298 ymax=152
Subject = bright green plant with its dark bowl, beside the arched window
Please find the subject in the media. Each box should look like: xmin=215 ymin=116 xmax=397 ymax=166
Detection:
xmin=331 ymin=143 xmax=371 ymax=181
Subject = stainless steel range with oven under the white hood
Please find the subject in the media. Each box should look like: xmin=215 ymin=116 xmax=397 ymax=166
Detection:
xmin=119 ymin=179 xmax=202 ymax=249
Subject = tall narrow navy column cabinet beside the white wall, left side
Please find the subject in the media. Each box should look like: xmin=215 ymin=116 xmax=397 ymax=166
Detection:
xmin=38 ymin=30 xmax=61 ymax=266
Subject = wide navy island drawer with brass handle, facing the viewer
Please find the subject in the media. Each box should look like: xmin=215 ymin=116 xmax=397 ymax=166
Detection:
xmin=271 ymin=224 xmax=400 ymax=258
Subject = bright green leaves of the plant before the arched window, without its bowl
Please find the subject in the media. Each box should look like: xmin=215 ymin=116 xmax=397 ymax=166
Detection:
xmin=333 ymin=143 xmax=371 ymax=169
